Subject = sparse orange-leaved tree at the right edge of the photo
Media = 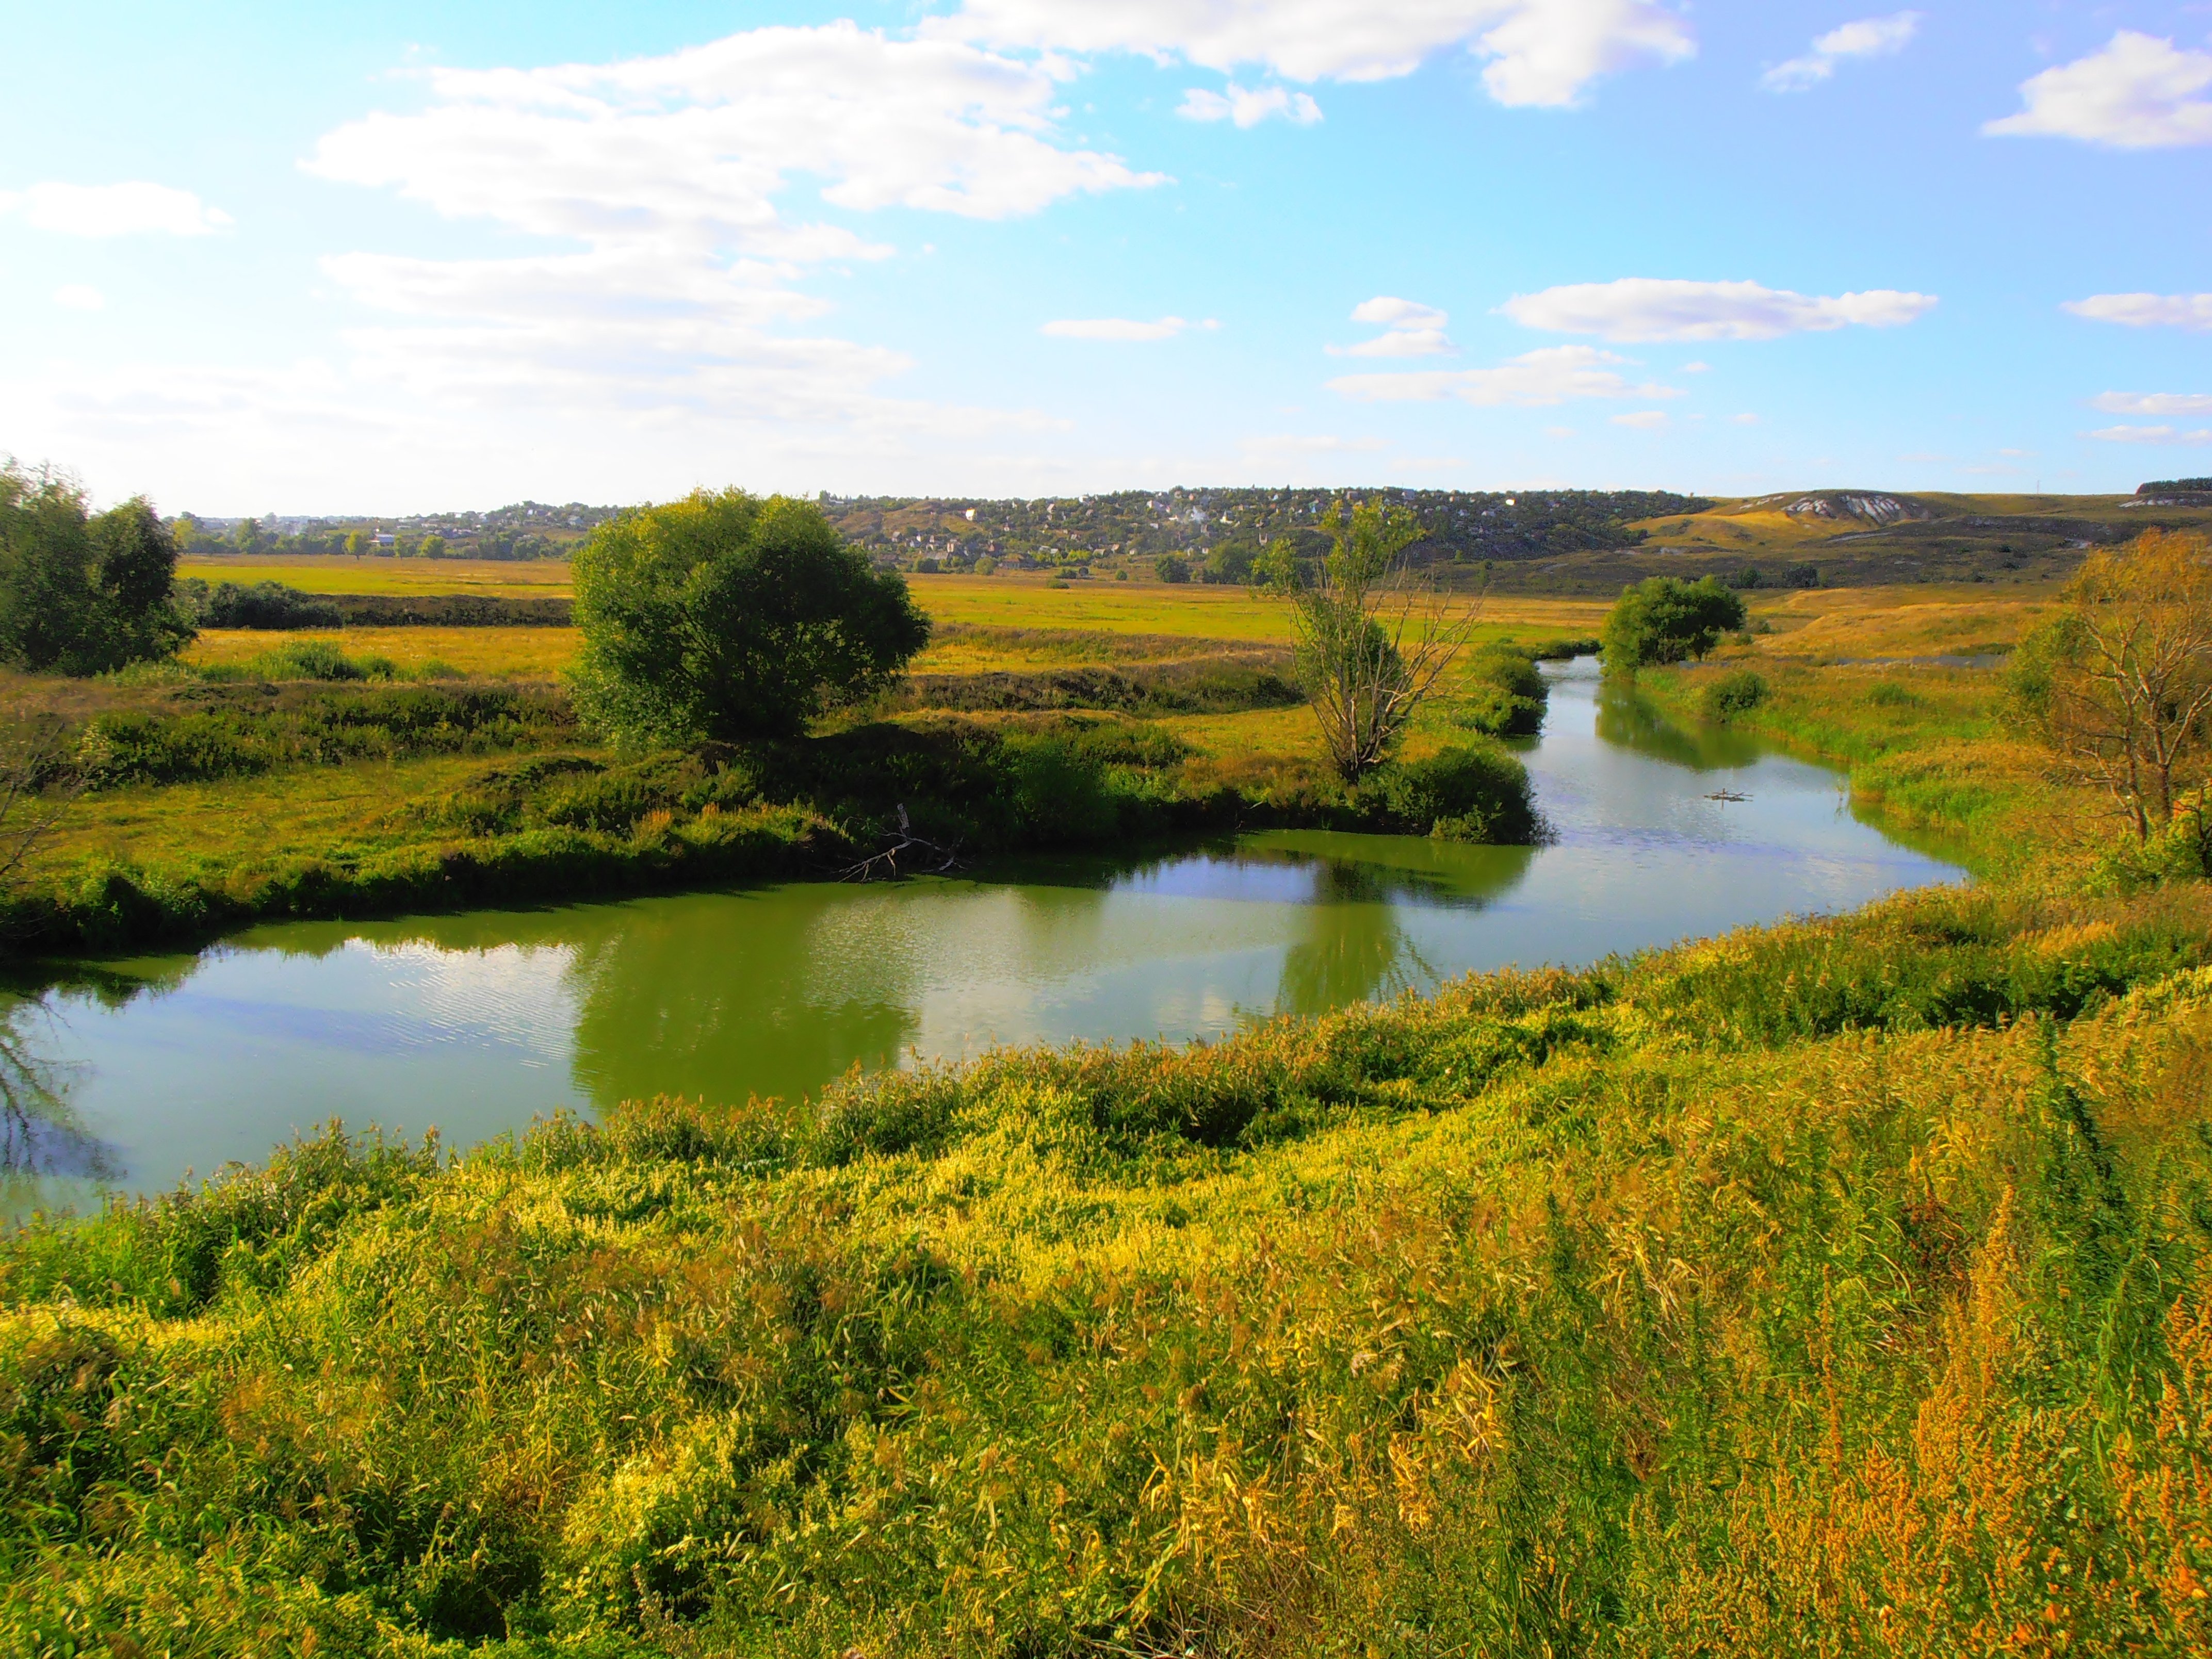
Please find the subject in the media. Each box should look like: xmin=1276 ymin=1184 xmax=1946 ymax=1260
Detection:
xmin=2015 ymin=531 xmax=2212 ymax=840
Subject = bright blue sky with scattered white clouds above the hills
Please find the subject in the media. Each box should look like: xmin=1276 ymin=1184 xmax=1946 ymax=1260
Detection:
xmin=0 ymin=0 xmax=2212 ymax=513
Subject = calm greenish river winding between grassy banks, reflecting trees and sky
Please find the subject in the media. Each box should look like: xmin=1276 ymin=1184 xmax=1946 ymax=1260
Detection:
xmin=0 ymin=661 xmax=1960 ymax=1216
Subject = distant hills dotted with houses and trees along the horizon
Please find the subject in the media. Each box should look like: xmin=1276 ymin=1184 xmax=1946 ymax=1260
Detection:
xmin=177 ymin=478 xmax=2212 ymax=593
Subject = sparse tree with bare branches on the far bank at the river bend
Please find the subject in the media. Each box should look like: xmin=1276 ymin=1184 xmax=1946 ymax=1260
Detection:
xmin=1265 ymin=502 xmax=1482 ymax=783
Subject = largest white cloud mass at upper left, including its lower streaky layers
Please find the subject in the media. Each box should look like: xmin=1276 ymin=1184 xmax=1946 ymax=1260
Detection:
xmin=305 ymin=22 xmax=1163 ymax=449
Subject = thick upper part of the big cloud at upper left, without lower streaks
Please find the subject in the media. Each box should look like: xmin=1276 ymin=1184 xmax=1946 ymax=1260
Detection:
xmin=305 ymin=22 xmax=1163 ymax=247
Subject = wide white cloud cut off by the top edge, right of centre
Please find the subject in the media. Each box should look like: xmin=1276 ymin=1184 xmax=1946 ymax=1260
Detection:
xmin=922 ymin=0 xmax=1697 ymax=106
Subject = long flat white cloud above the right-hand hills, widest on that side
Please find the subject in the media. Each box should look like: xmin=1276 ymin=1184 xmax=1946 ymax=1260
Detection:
xmin=1498 ymin=276 xmax=1935 ymax=340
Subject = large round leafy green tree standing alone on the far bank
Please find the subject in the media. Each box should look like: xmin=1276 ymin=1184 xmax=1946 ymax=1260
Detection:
xmin=571 ymin=489 xmax=929 ymax=743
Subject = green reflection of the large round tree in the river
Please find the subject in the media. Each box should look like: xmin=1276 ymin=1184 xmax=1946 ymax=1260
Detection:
xmin=568 ymin=891 xmax=920 ymax=1108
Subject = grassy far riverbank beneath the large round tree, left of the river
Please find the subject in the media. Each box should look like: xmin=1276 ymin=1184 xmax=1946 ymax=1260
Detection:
xmin=0 ymin=626 xmax=1539 ymax=953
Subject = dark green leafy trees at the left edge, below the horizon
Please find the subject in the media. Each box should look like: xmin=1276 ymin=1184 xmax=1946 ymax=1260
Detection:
xmin=0 ymin=464 xmax=192 ymax=675
